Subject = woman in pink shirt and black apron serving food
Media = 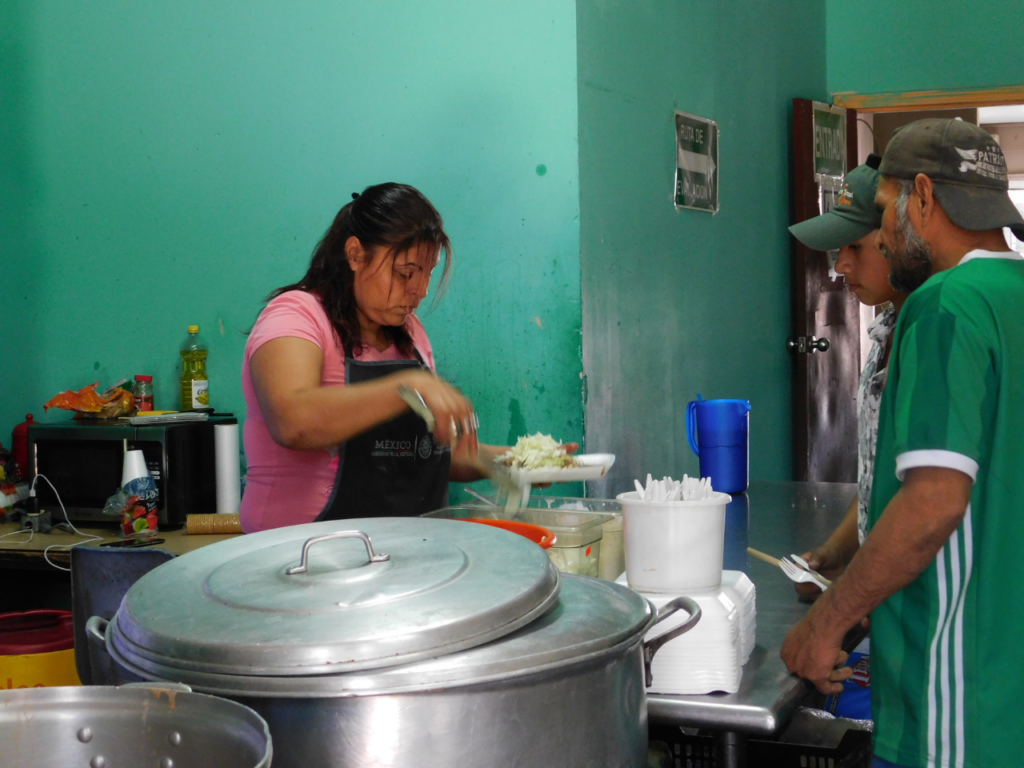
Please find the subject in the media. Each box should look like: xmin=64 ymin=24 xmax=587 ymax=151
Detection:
xmin=242 ymin=183 xmax=498 ymax=532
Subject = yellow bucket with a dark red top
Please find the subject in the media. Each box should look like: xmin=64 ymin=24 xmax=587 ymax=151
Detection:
xmin=0 ymin=610 xmax=82 ymax=689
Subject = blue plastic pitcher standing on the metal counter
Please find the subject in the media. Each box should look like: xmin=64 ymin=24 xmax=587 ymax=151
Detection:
xmin=686 ymin=394 xmax=751 ymax=494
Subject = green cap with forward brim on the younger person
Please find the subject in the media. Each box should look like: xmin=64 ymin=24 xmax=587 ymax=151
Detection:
xmin=790 ymin=155 xmax=882 ymax=251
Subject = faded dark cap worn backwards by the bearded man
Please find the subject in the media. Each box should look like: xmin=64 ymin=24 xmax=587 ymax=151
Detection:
xmin=879 ymin=118 xmax=1024 ymax=240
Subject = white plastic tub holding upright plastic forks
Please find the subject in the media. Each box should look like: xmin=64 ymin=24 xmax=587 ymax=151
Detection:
xmin=615 ymin=490 xmax=732 ymax=594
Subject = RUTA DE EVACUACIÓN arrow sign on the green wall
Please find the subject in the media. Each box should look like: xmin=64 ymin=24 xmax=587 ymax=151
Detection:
xmin=675 ymin=112 xmax=718 ymax=214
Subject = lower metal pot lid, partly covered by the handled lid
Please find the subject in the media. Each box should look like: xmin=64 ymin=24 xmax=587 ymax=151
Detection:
xmin=106 ymin=573 xmax=654 ymax=697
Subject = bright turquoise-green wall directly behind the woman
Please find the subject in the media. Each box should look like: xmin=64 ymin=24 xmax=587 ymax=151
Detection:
xmin=0 ymin=0 xmax=583 ymax=495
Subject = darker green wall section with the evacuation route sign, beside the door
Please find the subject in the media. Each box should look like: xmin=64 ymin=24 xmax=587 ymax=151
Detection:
xmin=577 ymin=0 xmax=825 ymax=495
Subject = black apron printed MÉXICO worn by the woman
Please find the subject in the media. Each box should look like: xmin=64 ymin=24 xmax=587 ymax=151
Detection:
xmin=316 ymin=352 xmax=452 ymax=521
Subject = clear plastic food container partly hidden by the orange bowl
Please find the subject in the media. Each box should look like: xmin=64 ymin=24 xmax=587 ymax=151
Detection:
xmin=424 ymin=505 xmax=617 ymax=578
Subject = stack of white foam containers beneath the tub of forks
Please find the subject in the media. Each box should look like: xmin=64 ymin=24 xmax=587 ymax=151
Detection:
xmin=620 ymin=570 xmax=756 ymax=694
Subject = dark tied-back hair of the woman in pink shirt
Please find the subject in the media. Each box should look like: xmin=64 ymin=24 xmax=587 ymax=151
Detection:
xmin=266 ymin=182 xmax=452 ymax=357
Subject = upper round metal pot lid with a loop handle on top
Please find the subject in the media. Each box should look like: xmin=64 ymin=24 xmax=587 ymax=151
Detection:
xmin=117 ymin=517 xmax=559 ymax=676
